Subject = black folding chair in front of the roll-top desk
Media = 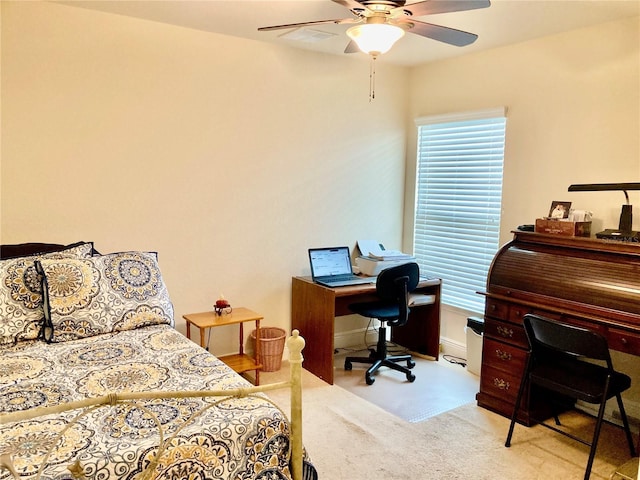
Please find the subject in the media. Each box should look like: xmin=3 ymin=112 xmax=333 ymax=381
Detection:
xmin=505 ymin=314 xmax=635 ymax=480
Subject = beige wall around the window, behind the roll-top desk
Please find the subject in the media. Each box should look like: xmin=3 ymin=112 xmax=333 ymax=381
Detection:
xmin=405 ymin=17 xmax=640 ymax=344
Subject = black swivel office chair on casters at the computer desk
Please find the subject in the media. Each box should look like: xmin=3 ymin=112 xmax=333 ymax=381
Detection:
xmin=344 ymin=263 xmax=420 ymax=385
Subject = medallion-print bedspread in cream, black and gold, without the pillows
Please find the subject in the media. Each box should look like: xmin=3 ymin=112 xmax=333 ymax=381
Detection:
xmin=0 ymin=325 xmax=300 ymax=480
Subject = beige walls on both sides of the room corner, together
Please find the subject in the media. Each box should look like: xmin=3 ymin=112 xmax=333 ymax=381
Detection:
xmin=0 ymin=1 xmax=640 ymax=372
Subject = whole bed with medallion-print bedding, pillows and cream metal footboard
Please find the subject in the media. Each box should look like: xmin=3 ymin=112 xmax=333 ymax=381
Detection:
xmin=0 ymin=242 xmax=317 ymax=480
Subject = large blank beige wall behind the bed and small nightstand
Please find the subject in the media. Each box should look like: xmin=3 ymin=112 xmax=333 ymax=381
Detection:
xmin=0 ymin=1 xmax=407 ymax=353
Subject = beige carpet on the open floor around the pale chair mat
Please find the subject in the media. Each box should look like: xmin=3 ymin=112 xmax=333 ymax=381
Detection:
xmin=262 ymin=362 xmax=629 ymax=480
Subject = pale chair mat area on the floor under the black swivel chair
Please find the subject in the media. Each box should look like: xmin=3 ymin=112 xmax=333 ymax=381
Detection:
xmin=334 ymin=350 xmax=480 ymax=423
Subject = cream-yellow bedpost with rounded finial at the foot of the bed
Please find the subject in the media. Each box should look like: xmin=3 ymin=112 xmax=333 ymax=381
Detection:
xmin=287 ymin=330 xmax=305 ymax=480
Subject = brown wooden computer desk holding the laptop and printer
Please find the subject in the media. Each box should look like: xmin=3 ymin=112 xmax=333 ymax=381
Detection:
xmin=291 ymin=277 xmax=441 ymax=384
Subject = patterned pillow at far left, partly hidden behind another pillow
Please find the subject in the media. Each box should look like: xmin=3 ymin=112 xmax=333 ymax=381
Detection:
xmin=0 ymin=242 xmax=93 ymax=344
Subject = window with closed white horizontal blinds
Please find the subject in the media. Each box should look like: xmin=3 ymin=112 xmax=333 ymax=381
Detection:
xmin=413 ymin=108 xmax=506 ymax=313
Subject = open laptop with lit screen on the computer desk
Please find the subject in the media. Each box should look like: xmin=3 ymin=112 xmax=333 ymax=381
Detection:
xmin=309 ymin=247 xmax=376 ymax=287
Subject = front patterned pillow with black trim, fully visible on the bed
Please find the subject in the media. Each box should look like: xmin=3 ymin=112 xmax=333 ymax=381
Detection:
xmin=36 ymin=252 xmax=173 ymax=342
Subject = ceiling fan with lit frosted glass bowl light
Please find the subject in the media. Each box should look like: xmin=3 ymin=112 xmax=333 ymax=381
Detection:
xmin=258 ymin=0 xmax=491 ymax=57
